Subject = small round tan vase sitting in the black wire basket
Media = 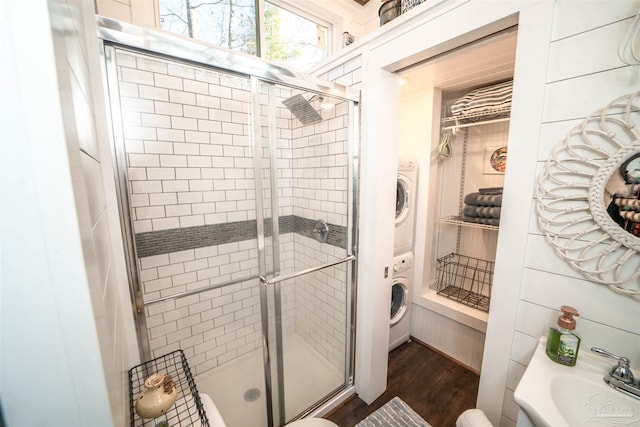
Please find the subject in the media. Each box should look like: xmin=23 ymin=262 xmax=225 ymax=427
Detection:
xmin=136 ymin=373 xmax=178 ymax=419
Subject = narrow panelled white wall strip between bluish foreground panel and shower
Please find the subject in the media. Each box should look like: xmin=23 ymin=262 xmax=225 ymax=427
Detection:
xmin=50 ymin=0 xmax=138 ymax=424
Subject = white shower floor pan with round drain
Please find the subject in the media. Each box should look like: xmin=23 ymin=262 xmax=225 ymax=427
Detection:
xmin=196 ymin=334 xmax=344 ymax=427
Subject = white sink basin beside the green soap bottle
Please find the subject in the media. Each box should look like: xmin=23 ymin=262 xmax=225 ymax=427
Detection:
xmin=514 ymin=337 xmax=640 ymax=427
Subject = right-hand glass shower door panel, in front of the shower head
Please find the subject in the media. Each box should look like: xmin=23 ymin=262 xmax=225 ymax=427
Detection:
xmin=254 ymin=82 xmax=354 ymax=425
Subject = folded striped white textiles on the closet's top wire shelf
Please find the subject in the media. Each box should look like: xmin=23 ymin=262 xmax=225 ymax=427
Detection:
xmin=451 ymin=80 xmax=513 ymax=116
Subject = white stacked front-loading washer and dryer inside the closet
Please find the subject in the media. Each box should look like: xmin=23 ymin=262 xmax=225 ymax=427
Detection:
xmin=389 ymin=156 xmax=418 ymax=351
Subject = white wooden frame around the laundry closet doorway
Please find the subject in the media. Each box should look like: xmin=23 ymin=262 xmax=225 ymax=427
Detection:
xmin=314 ymin=0 xmax=554 ymax=425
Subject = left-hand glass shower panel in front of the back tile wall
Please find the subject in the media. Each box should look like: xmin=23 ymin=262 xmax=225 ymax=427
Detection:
xmin=105 ymin=45 xmax=276 ymax=427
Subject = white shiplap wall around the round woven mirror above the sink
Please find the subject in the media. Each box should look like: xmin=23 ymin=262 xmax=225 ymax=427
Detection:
xmin=500 ymin=0 xmax=640 ymax=427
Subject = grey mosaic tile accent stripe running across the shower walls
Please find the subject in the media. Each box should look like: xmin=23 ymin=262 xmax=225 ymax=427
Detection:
xmin=135 ymin=215 xmax=347 ymax=258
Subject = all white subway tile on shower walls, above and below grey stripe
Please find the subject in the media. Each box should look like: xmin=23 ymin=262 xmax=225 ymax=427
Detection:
xmin=117 ymin=52 xmax=350 ymax=374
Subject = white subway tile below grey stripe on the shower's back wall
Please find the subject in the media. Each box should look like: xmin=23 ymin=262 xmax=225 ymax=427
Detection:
xmin=140 ymin=239 xmax=262 ymax=374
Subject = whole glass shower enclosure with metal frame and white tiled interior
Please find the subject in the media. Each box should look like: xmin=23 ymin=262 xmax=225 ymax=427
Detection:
xmin=99 ymin=18 xmax=358 ymax=427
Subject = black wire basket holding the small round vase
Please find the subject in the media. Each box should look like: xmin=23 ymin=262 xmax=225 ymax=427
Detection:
xmin=129 ymin=350 xmax=209 ymax=427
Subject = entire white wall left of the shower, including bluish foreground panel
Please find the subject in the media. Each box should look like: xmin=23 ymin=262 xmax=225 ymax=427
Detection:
xmin=0 ymin=0 xmax=138 ymax=426
